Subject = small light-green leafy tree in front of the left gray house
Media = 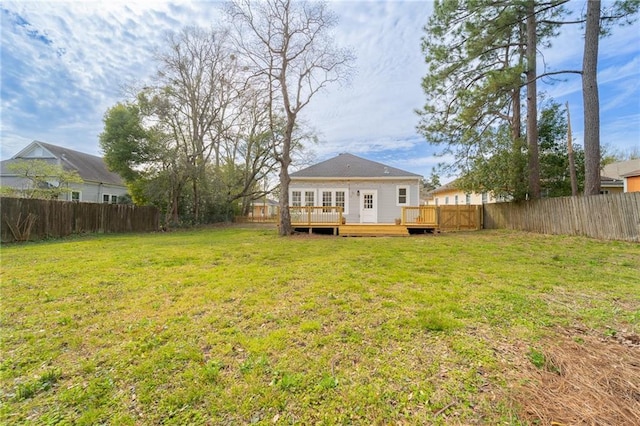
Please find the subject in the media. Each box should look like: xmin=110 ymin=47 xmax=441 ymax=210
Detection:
xmin=7 ymin=160 xmax=84 ymax=199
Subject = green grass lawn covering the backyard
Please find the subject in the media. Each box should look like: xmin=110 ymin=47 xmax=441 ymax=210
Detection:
xmin=0 ymin=228 xmax=640 ymax=425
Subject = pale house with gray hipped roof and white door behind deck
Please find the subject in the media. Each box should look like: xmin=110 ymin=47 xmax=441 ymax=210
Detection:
xmin=289 ymin=153 xmax=422 ymax=224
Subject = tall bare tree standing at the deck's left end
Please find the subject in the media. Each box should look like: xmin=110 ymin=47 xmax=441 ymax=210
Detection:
xmin=228 ymin=0 xmax=354 ymax=235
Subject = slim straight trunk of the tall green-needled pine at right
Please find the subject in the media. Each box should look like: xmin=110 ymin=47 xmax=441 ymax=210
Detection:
xmin=526 ymin=1 xmax=540 ymax=200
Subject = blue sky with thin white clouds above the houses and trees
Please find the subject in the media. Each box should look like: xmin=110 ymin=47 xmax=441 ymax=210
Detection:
xmin=0 ymin=0 xmax=640 ymax=183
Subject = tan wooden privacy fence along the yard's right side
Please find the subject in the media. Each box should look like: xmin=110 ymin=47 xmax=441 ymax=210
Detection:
xmin=484 ymin=192 xmax=640 ymax=242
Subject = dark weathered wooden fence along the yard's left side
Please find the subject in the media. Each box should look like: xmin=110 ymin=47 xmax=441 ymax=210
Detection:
xmin=0 ymin=197 xmax=160 ymax=243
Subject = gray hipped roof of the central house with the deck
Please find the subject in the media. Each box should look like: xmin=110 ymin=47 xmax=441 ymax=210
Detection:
xmin=290 ymin=153 xmax=422 ymax=179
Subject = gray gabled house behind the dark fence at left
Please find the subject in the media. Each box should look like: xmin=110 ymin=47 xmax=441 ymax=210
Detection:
xmin=0 ymin=141 xmax=127 ymax=204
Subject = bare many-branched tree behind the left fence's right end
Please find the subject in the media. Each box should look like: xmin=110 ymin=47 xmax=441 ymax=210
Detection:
xmin=154 ymin=27 xmax=239 ymax=221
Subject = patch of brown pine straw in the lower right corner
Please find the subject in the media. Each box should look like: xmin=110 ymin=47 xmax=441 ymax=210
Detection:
xmin=514 ymin=329 xmax=640 ymax=426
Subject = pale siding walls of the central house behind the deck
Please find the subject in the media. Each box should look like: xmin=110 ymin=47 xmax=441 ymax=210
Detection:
xmin=289 ymin=178 xmax=420 ymax=223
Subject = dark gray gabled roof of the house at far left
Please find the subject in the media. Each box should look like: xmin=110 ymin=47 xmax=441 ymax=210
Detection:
xmin=0 ymin=141 xmax=124 ymax=186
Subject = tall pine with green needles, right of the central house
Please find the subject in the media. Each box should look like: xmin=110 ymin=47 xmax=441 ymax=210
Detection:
xmin=418 ymin=0 xmax=565 ymax=197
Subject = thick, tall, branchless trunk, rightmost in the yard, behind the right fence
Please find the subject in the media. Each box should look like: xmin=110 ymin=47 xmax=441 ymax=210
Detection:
xmin=582 ymin=0 xmax=600 ymax=195
